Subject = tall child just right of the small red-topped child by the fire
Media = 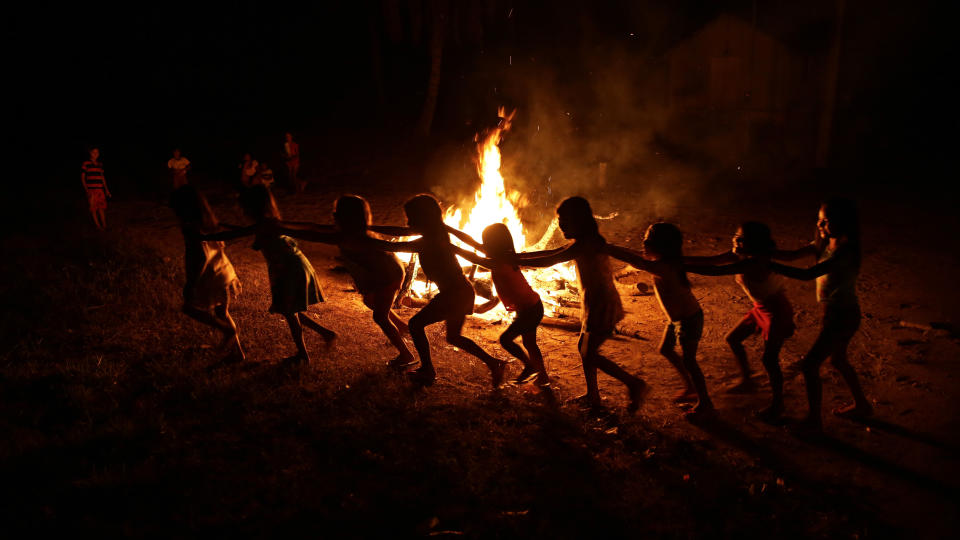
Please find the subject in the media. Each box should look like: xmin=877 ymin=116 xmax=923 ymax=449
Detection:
xmin=519 ymin=197 xmax=648 ymax=412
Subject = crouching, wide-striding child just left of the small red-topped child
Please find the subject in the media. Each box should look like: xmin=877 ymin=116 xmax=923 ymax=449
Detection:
xmin=356 ymin=194 xmax=505 ymax=388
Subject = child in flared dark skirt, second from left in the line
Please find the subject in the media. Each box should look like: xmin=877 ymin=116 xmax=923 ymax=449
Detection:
xmin=201 ymin=185 xmax=337 ymax=363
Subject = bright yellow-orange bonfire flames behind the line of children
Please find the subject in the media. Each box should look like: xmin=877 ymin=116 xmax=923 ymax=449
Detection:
xmin=411 ymin=107 xmax=576 ymax=319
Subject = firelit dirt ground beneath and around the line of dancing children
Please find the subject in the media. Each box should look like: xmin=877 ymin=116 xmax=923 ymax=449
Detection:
xmin=2 ymin=172 xmax=960 ymax=538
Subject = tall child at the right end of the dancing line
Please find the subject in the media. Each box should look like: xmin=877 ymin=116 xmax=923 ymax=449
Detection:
xmin=770 ymin=199 xmax=873 ymax=431
